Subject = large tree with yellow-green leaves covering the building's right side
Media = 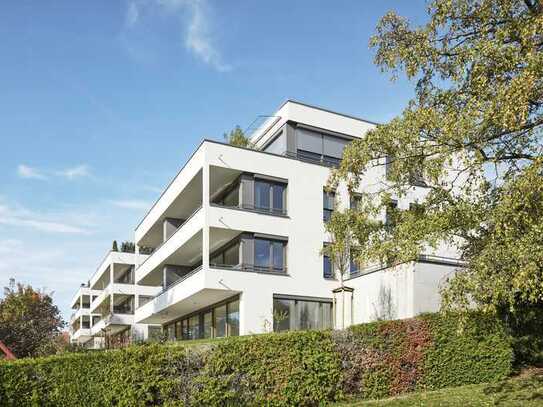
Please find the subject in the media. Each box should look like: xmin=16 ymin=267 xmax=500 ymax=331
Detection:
xmin=330 ymin=0 xmax=543 ymax=312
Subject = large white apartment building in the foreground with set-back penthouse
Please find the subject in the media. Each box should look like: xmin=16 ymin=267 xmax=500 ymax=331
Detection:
xmin=129 ymin=100 xmax=460 ymax=339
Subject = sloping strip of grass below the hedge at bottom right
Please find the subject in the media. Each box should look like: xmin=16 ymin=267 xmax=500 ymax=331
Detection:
xmin=337 ymin=370 xmax=543 ymax=407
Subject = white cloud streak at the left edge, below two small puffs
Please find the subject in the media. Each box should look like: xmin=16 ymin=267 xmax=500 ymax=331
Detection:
xmin=0 ymin=202 xmax=90 ymax=235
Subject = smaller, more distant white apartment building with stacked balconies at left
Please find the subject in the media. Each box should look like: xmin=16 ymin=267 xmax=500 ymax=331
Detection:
xmin=70 ymin=251 xmax=161 ymax=348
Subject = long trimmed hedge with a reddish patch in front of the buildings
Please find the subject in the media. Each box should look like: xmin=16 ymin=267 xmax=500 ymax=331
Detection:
xmin=0 ymin=314 xmax=513 ymax=406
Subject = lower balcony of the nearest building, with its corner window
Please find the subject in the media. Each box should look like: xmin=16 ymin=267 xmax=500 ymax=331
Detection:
xmin=135 ymin=227 xmax=288 ymax=324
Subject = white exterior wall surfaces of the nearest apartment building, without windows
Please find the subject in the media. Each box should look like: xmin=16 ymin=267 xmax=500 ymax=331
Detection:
xmin=129 ymin=102 xmax=464 ymax=334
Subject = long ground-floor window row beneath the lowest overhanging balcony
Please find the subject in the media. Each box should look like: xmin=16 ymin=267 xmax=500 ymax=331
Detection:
xmin=164 ymin=298 xmax=239 ymax=340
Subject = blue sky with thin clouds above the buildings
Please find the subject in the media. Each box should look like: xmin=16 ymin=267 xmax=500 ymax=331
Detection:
xmin=0 ymin=0 xmax=432 ymax=319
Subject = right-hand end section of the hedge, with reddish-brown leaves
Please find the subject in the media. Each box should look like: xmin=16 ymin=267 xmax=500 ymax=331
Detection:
xmin=336 ymin=314 xmax=513 ymax=398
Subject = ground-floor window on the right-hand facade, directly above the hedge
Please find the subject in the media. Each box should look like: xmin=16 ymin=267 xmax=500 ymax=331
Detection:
xmin=273 ymin=296 xmax=332 ymax=332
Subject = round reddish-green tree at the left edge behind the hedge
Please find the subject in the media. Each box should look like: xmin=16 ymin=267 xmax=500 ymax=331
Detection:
xmin=0 ymin=279 xmax=65 ymax=358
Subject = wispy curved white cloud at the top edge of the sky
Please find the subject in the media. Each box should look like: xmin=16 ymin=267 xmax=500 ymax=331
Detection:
xmin=125 ymin=0 xmax=232 ymax=72
